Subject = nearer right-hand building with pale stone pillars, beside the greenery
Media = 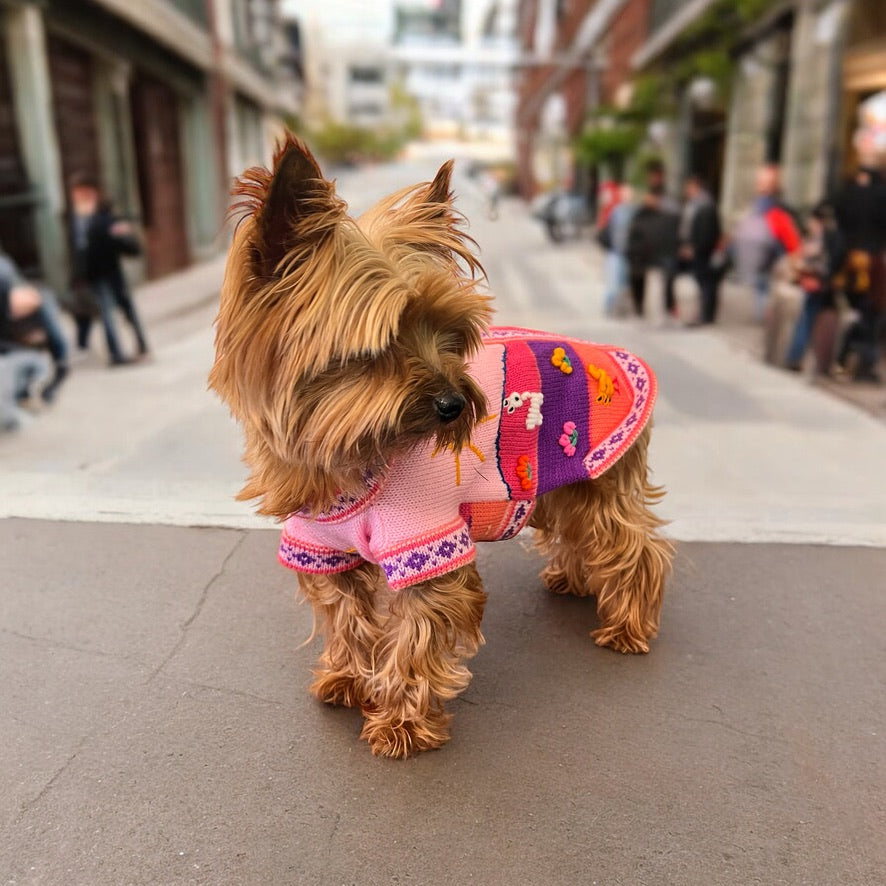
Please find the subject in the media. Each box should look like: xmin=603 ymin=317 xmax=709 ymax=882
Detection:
xmin=632 ymin=0 xmax=886 ymax=221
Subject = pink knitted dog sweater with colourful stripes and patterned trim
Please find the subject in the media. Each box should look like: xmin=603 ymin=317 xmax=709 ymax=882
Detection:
xmin=278 ymin=327 xmax=656 ymax=590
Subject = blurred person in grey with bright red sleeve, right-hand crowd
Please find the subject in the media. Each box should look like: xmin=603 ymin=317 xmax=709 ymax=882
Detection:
xmin=730 ymin=163 xmax=801 ymax=321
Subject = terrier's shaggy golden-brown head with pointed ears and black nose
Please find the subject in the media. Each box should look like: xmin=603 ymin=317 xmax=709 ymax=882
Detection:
xmin=210 ymin=136 xmax=491 ymax=517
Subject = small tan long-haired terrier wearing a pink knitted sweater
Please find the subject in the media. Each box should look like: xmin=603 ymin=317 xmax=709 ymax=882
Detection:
xmin=210 ymin=136 xmax=673 ymax=757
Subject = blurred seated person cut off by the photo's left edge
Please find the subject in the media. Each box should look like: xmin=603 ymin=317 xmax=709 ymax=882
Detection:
xmin=0 ymin=254 xmax=69 ymax=403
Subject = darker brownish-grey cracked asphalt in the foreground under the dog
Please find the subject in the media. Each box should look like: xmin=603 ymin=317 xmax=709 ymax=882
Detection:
xmin=0 ymin=520 xmax=886 ymax=886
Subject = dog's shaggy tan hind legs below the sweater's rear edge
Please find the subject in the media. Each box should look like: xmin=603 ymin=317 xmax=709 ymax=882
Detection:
xmin=532 ymin=428 xmax=674 ymax=652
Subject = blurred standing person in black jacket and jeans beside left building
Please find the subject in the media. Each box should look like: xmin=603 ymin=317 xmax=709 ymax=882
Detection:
xmin=69 ymin=175 xmax=148 ymax=366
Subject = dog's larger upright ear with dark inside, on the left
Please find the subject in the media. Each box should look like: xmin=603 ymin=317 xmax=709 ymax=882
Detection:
xmin=233 ymin=134 xmax=344 ymax=277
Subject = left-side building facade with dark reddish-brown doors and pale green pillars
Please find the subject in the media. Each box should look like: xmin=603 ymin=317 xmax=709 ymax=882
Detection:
xmin=0 ymin=0 xmax=297 ymax=288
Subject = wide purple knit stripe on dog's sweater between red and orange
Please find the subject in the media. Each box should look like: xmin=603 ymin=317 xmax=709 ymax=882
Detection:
xmin=529 ymin=341 xmax=591 ymax=495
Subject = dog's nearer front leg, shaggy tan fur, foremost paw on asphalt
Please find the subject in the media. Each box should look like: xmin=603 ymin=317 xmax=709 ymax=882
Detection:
xmin=361 ymin=564 xmax=486 ymax=757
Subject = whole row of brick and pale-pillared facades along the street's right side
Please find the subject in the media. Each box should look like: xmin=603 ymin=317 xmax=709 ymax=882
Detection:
xmin=517 ymin=0 xmax=886 ymax=222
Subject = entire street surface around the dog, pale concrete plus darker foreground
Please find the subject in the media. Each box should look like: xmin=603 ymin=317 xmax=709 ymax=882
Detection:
xmin=0 ymin=160 xmax=886 ymax=886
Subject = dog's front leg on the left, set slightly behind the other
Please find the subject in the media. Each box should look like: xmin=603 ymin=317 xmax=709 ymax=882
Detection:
xmin=299 ymin=563 xmax=385 ymax=707
